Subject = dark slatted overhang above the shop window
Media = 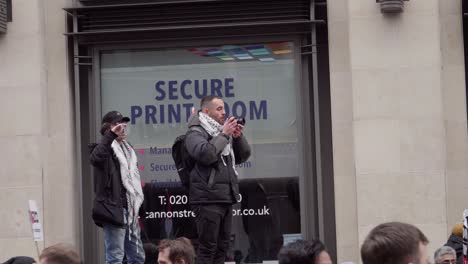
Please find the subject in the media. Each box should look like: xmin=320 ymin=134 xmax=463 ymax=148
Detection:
xmin=65 ymin=0 xmax=324 ymax=42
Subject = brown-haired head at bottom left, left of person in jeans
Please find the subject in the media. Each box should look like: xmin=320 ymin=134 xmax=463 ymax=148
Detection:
xmin=39 ymin=243 xmax=81 ymax=264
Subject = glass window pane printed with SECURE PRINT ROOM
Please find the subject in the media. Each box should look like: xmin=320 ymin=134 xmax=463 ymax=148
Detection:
xmin=101 ymin=42 xmax=302 ymax=263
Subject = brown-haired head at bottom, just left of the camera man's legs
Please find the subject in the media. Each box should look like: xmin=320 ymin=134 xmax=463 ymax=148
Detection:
xmin=158 ymin=237 xmax=195 ymax=264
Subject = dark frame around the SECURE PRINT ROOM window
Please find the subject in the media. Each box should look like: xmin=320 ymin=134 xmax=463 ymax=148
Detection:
xmin=81 ymin=35 xmax=330 ymax=263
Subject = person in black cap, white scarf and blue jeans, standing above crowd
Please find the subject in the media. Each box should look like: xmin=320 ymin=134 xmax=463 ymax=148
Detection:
xmin=90 ymin=111 xmax=145 ymax=264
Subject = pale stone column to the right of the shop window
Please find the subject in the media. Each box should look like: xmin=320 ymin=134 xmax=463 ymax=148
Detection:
xmin=328 ymin=0 xmax=468 ymax=262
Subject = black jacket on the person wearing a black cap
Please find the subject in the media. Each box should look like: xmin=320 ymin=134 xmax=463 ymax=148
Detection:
xmin=89 ymin=131 xmax=127 ymax=226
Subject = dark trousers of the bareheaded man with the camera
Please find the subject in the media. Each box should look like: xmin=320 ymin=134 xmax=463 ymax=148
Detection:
xmin=192 ymin=204 xmax=232 ymax=264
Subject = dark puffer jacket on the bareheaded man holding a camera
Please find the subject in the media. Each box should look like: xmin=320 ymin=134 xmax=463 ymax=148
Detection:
xmin=185 ymin=115 xmax=250 ymax=204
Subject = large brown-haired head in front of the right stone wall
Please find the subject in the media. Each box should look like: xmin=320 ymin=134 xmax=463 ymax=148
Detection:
xmin=361 ymin=222 xmax=429 ymax=264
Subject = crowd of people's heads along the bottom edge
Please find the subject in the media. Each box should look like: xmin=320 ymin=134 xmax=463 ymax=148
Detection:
xmin=4 ymin=219 xmax=463 ymax=264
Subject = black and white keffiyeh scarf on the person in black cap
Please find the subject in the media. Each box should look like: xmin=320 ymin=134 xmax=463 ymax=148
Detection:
xmin=111 ymin=140 xmax=144 ymax=251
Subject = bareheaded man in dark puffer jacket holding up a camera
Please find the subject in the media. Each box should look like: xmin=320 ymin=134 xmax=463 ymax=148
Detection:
xmin=185 ymin=96 xmax=250 ymax=264
